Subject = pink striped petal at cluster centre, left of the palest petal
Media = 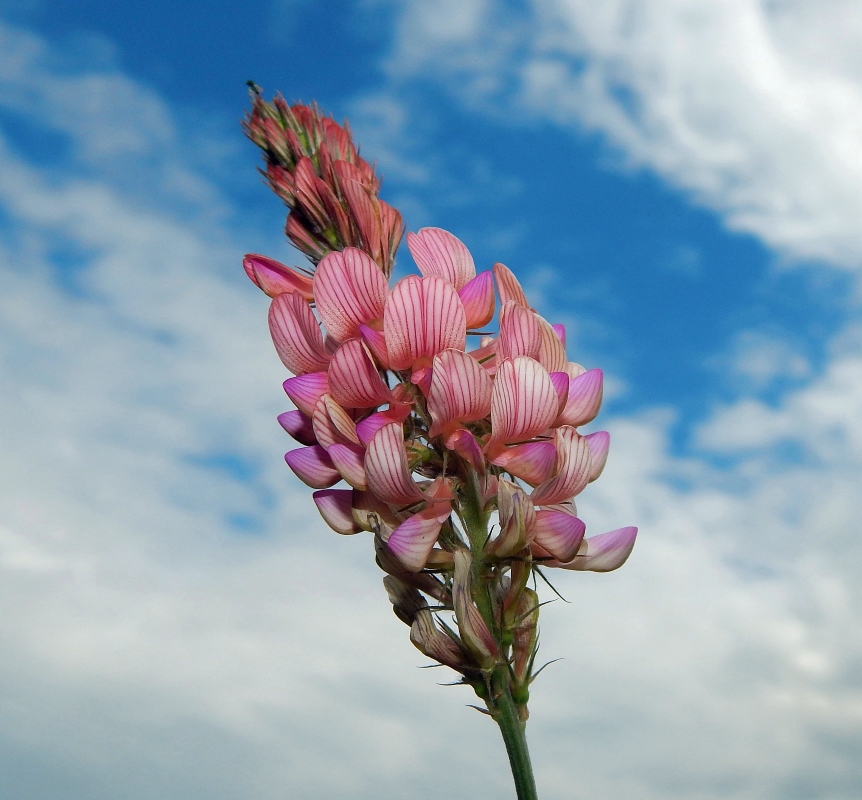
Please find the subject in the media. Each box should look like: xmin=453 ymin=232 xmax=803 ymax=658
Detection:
xmin=428 ymin=350 xmax=493 ymax=436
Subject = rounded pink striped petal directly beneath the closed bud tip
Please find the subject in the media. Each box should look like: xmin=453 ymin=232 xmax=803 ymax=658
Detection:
xmin=314 ymin=247 xmax=386 ymax=342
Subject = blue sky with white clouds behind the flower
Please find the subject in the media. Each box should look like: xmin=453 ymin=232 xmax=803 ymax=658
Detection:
xmin=0 ymin=0 xmax=862 ymax=800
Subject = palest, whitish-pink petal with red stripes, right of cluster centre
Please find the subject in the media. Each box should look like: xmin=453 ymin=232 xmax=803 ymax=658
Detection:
xmin=491 ymin=356 xmax=557 ymax=444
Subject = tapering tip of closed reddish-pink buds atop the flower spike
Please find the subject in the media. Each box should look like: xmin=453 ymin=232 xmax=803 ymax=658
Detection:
xmin=244 ymin=84 xmax=404 ymax=270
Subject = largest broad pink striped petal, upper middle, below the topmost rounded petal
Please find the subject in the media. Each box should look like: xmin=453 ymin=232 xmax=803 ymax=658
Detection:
xmin=383 ymin=275 xmax=467 ymax=370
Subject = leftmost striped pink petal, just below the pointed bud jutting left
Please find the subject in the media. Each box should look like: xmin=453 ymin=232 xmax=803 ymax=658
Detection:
xmin=269 ymin=292 xmax=329 ymax=375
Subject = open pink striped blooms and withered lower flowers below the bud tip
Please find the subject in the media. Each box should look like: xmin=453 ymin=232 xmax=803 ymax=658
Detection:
xmin=244 ymin=228 xmax=637 ymax=719
